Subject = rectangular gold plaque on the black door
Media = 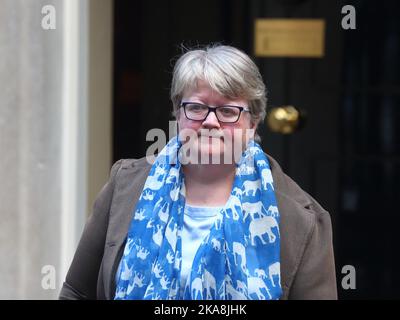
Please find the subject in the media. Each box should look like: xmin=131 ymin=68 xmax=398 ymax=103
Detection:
xmin=255 ymin=18 xmax=325 ymax=58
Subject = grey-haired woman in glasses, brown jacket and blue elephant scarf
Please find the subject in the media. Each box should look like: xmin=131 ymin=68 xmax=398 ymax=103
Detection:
xmin=60 ymin=46 xmax=337 ymax=300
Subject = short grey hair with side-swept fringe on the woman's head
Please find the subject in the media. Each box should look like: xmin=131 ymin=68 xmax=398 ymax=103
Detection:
xmin=171 ymin=45 xmax=267 ymax=142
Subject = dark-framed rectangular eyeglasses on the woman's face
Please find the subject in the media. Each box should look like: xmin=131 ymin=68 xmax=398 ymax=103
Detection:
xmin=181 ymin=102 xmax=250 ymax=123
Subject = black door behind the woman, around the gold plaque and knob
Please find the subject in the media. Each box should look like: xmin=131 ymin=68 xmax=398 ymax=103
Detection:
xmin=114 ymin=0 xmax=400 ymax=299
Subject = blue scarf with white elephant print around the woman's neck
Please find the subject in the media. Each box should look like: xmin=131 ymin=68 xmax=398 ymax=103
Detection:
xmin=115 ymin=137 xmax=282 ymax=300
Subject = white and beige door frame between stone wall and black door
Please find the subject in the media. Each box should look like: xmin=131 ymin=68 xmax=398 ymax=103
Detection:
xmin=58 ymin=0 xmax=113 ymax=286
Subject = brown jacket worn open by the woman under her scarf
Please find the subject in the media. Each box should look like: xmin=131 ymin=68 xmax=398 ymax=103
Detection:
xmin=60 ymin=155 xmax=337 ymax=299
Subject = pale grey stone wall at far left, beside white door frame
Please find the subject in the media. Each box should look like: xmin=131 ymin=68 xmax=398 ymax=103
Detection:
xmin=0 ymin=0 xmax=75 ymax=299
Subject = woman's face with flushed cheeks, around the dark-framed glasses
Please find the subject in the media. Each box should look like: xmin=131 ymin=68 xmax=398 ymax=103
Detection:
xmin=177 ymin=80 xmax=257 ymax=164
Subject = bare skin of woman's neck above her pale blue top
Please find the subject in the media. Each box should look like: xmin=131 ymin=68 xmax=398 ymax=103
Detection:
xmin=183 ymin=164 xmax=236 ymax=207
